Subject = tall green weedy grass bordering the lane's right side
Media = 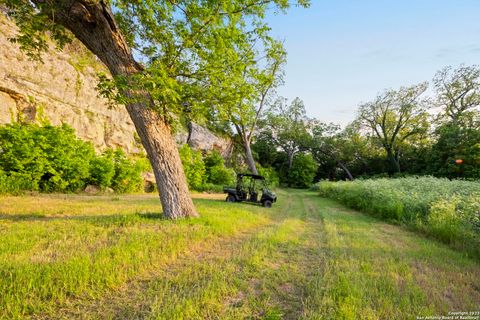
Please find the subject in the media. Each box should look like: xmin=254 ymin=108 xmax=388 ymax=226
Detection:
xmin=317 ymin=177 xmax=480 ymax=257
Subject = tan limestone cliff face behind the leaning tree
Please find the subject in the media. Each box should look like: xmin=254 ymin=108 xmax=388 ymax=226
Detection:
xmin=0 ymin=12 xmax=232 ymax=157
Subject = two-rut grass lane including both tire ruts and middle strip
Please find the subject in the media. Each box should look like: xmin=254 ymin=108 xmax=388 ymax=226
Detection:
xmin=52 ymin=191 xmax=332 ymax=319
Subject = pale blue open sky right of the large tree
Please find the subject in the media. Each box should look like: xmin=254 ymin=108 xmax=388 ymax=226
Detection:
xmin=268 ymin=0 xmax=480 ymax=125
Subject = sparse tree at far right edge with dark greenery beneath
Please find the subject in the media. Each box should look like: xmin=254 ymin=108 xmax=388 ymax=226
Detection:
xmin=427 ymin=66 xmax=480 ymax=179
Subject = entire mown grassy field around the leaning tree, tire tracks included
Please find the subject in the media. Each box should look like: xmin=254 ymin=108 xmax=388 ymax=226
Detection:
xmin=0 ymin=190 xmax=480 ymax=319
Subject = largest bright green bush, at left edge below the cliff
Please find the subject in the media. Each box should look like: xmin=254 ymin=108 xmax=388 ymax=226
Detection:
xmin=0 ymin=123 xmax=95 ymax=192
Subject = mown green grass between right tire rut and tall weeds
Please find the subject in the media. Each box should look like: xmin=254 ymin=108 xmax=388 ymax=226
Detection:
xmin=306 ymin=196 xmax=480 ymax=319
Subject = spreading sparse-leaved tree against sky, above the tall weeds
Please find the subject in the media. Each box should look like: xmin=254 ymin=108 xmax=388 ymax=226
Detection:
xmin=357 ymin=83 xmax=430 ymax=173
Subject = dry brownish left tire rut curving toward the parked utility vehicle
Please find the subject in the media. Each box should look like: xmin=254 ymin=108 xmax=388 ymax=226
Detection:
xmin=47 ymin=191 xmax=291 ymax=319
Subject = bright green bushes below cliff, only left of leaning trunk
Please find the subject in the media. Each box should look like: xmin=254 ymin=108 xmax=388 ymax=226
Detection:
xmin=0 ymin=123 xmax=146 ymax=193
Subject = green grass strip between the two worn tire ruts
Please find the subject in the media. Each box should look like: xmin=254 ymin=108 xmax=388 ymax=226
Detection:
xmin=140 ymin=194 xmax=304 ymax=319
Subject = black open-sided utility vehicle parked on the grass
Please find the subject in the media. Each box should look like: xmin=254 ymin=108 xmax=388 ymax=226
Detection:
xmin=223 ymin=173 xmax=277 ymax=208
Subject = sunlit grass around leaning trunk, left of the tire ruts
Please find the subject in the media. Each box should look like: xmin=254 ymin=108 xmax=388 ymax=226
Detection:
xmin=0 ymin=191 xmax=268 ymax=318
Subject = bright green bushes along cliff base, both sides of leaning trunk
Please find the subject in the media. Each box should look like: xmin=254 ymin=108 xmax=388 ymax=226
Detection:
xmin=0 ymin=123 xmax=235 ymax=194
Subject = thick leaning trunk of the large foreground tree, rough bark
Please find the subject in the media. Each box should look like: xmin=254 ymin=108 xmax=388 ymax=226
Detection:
xmin=38 ymin=0 xmax=198 ymax=219
